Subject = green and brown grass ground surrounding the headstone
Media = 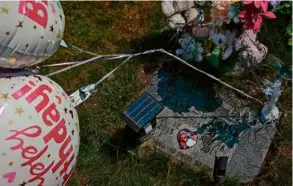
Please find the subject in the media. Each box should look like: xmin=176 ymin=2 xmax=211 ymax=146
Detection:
xmin=42 ymin=1 xmax=292 ymax=186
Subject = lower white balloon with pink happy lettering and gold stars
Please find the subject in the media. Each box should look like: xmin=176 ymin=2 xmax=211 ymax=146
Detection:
xmin=0 ymin=75 xmax=80 ymax=186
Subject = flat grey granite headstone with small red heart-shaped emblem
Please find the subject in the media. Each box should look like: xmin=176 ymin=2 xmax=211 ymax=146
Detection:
xmin=141 ymin=70 xmax=275 ymax=181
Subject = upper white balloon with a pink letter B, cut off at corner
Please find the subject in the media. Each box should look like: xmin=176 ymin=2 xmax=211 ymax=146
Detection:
xmin=0 ymin=0 xmax=65 ymax=68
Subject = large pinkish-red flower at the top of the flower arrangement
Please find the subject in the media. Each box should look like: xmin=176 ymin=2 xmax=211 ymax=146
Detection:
xmin=238 ymin=0 xmax=276 ymax=33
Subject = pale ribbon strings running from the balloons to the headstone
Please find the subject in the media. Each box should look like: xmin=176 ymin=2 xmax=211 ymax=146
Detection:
xmin=54 ymin=49 xmax=263 ymax=104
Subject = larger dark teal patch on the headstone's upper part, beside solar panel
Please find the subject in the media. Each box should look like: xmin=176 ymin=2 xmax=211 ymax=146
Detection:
xmin=155 ymin=70 xmax=223 ymax=113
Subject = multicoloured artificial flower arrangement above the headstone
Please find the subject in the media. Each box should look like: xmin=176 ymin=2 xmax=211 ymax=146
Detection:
xmin=162 ymin=0 xmax=282 ymax=71
